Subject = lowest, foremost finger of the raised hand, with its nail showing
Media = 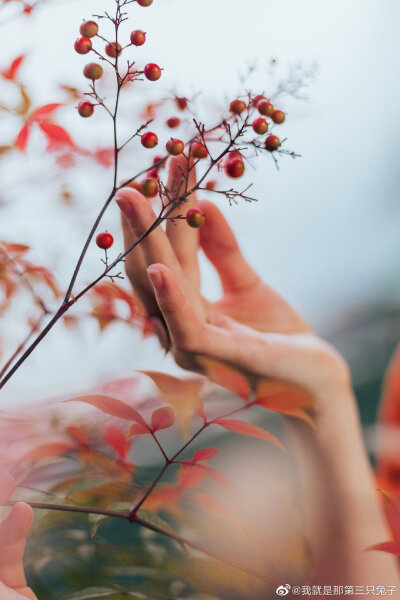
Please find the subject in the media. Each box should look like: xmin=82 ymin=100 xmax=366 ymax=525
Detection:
xmin=147 ymin=264 xmax=205 ymax=352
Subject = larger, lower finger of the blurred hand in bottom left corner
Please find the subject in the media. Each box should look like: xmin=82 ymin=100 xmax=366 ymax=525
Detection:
xmin=0 ymin=502 xmax=33 ymax=588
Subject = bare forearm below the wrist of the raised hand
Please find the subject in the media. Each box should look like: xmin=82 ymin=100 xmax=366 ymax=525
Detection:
xmin=288 ymin=390 xmax=399 ymax=586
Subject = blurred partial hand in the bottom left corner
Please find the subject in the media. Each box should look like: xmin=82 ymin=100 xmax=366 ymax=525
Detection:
xmin=0 ymin=471 xmax=37 ymax=600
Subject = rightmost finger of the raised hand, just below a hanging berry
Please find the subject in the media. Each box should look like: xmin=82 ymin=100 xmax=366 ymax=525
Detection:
xmin=199 ymin=201 xmax=259 ymax=292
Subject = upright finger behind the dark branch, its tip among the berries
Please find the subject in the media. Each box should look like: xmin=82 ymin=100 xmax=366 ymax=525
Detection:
xmin=166 ymin=155 xmax=200 ymax=287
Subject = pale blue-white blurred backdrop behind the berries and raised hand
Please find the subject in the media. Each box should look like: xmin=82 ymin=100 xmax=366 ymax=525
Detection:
xmin=0 ymin=0 xmax=400 ymax=422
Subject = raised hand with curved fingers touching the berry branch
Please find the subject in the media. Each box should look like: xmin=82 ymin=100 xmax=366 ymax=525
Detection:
xmin=117 ymin=157 xmax=350 ymax=410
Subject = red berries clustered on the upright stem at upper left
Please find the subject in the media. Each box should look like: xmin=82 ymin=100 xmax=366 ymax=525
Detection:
xmin=74 ymin=14 xmax=162 ymax=117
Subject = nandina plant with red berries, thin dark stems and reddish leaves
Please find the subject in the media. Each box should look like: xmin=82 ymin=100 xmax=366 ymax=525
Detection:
xmin=0 ymin=0 xmax=322 ymax=598
